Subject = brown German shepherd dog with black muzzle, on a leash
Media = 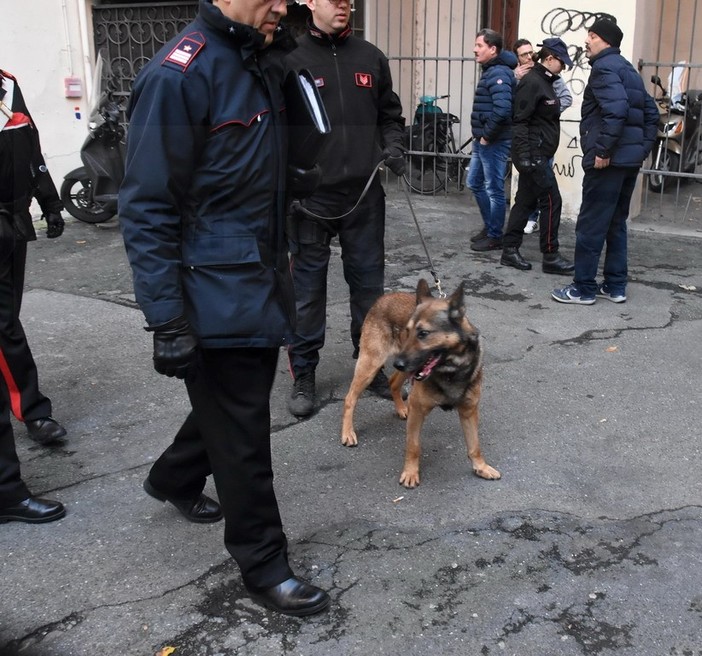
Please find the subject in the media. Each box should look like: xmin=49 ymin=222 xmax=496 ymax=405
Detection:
xmin=341 ymin=280 xmax=500 ymax=488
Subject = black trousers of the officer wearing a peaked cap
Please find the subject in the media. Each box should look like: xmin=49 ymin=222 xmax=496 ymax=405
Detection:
xmin=502 ymin=166 xmax=563 ymax=254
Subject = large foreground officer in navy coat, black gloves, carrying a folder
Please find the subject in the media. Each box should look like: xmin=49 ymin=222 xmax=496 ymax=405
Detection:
xmin=119 ymin=0 xmax=329 ymax=615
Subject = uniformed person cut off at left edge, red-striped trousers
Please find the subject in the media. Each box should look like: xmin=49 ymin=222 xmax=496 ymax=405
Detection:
xmin=0 ymin=70 xmax=66 ymax=522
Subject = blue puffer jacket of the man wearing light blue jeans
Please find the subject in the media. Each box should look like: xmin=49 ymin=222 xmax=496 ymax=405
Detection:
xmin=470 ymin=50 xmax=517 ymax=141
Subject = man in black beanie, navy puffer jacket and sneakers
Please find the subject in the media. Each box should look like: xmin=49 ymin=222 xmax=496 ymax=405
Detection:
xmin=551 ymin=19 xmax=659 ymax=305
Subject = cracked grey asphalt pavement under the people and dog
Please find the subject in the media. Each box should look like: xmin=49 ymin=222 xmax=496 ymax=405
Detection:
xmin=0 ymin=188 xmax=702 ymax=656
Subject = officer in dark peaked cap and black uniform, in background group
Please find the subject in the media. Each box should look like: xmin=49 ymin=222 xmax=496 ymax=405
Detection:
xmin=500 ymin=38 xmax=573 ymax=273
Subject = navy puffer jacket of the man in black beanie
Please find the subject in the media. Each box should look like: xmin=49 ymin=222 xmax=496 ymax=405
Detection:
xmin=580 ymin=48 xmax=659 ymax=170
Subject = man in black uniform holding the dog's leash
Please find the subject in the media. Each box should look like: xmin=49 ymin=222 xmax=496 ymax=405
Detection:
xmin=286 ymin=0 xmax=405 ymax=417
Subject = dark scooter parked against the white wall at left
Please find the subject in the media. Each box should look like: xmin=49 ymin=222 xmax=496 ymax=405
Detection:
xmin=61 ymin=57 xmax=126 ymax=223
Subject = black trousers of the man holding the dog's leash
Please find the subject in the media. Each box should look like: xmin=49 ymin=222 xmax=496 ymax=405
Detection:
xmin=288 ymin=176 xmax=385 ymax=375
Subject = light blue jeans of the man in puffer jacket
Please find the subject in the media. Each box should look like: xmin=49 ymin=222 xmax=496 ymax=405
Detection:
xmin=466 ymin=139 xmax=511 ymax=239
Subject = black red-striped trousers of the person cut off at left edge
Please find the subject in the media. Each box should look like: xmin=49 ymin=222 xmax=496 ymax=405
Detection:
xmin=0 ymin=240 xmax=51 ymax=507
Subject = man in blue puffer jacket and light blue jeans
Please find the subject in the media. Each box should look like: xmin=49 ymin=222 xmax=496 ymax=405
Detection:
xmin=466 ymin=29 xmax=517 ymax=251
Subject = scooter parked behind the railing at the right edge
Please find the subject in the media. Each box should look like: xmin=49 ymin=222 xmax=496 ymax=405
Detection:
xmin=648 ymin=75 xmax=702 ymax=193
